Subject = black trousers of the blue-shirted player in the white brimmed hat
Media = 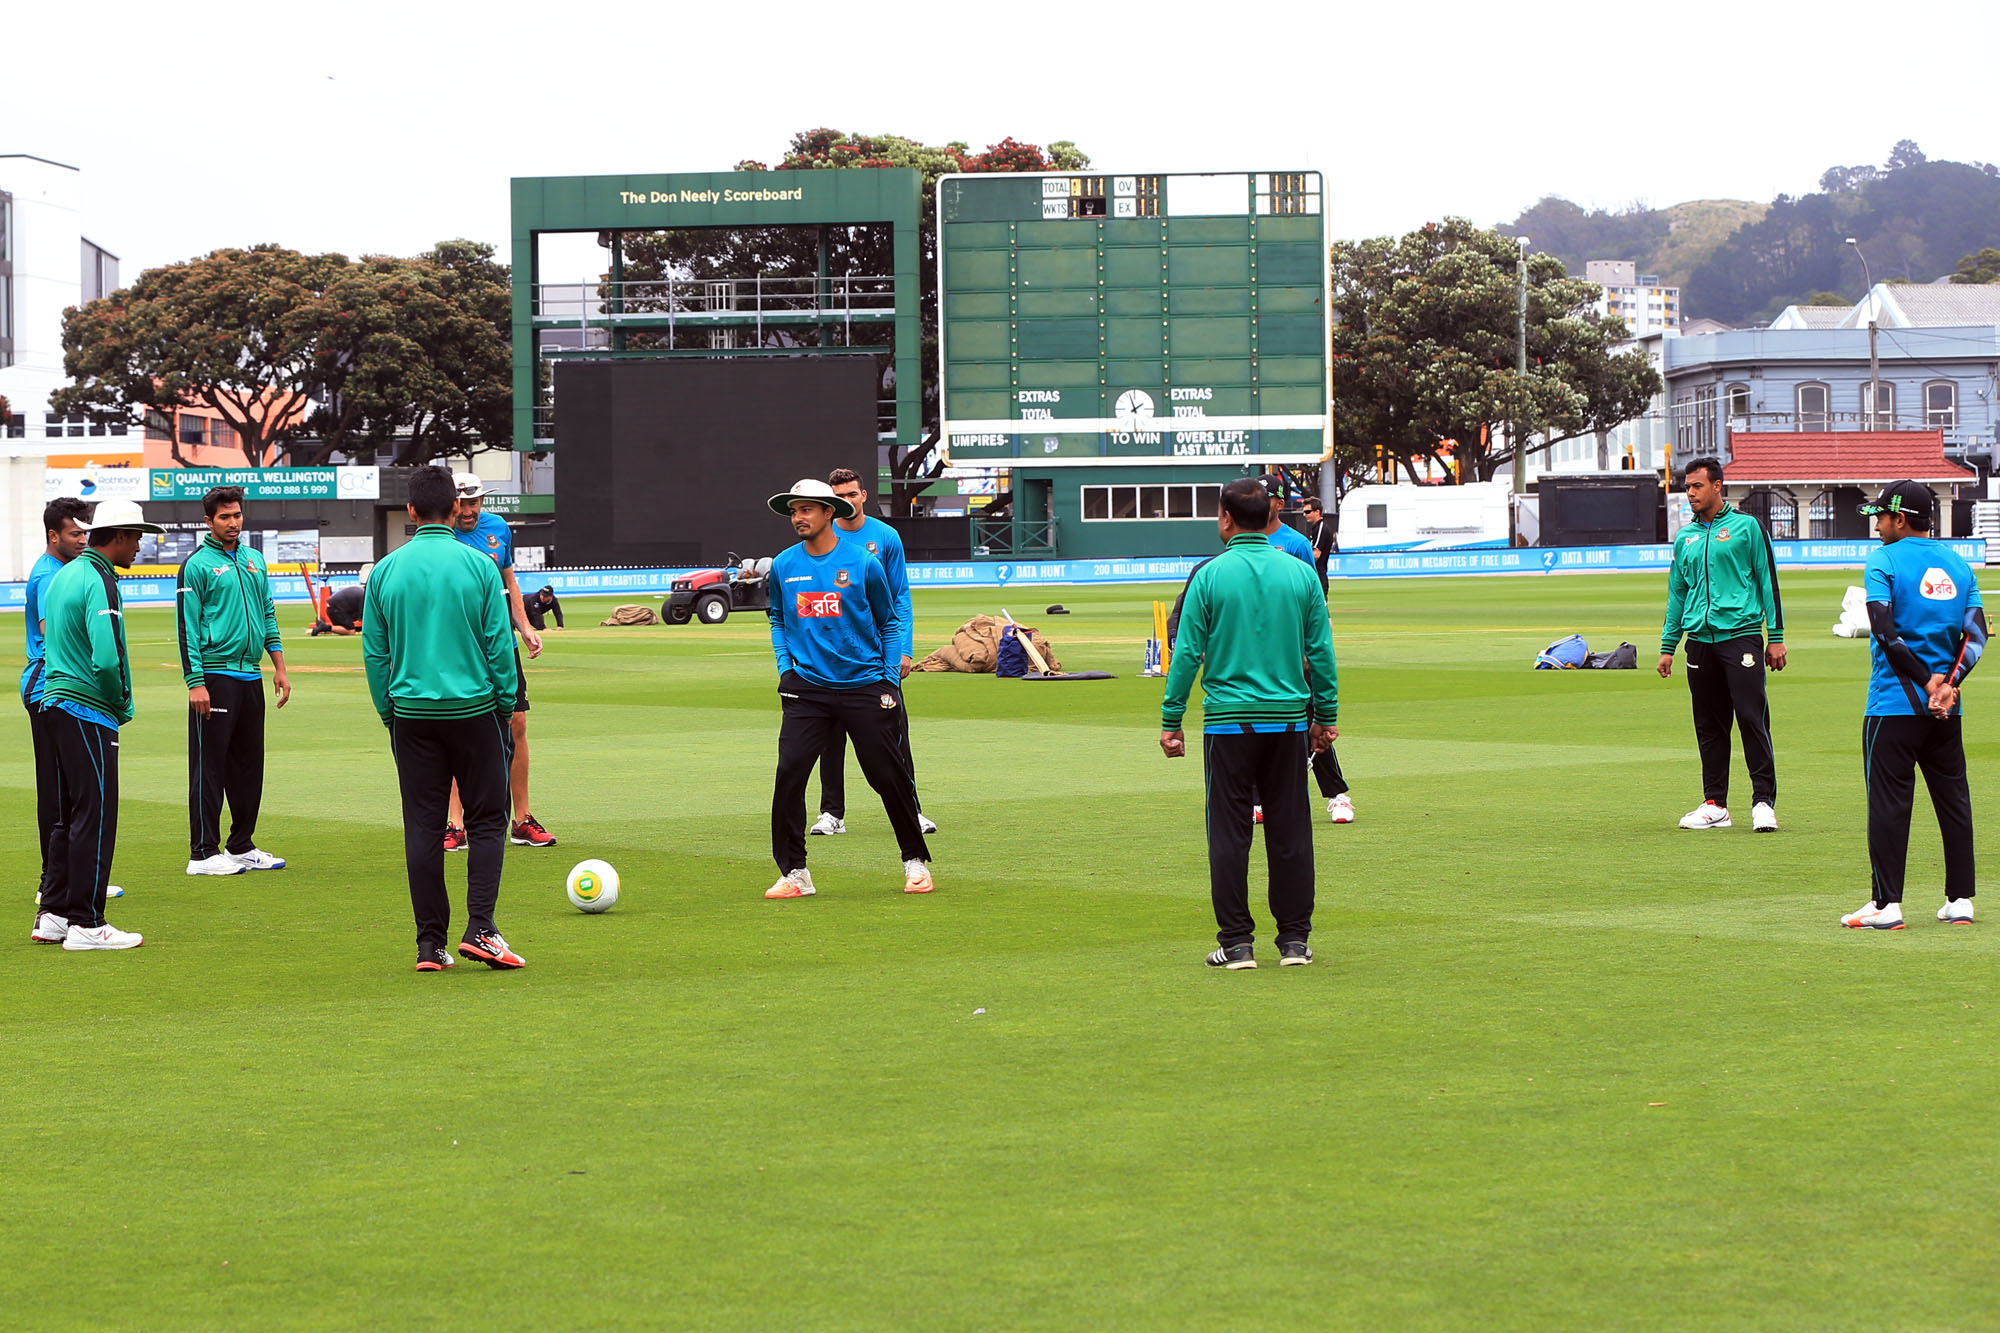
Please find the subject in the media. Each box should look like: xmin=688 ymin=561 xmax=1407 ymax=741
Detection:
xmin=770 ymin=671 xmax=930 ymax=875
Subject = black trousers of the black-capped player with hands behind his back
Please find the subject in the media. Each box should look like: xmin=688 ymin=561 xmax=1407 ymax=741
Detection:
xmin=1862 ymin=717 xmax=1974 ymax=903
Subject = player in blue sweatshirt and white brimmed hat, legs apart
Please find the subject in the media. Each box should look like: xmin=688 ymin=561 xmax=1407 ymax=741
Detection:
xmin=764 ymin=480 xmax=932 ymax=899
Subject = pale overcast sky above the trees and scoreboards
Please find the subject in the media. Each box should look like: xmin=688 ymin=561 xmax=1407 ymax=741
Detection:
xmin=15 ymin=0 xmax=2000 ymax=282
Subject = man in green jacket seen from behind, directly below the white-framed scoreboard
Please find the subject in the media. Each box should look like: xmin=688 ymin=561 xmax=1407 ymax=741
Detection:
xmin=1160 ymin=476 xmax=1340 ymax=971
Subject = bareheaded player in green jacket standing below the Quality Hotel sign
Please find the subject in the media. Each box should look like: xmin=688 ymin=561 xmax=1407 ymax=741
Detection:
xmin=174 ymin=486 xmax=292 ymax=875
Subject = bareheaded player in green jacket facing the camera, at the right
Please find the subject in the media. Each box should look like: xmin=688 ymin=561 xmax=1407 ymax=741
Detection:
xmin=1660 ymin=458 xmax=1784 ymax=833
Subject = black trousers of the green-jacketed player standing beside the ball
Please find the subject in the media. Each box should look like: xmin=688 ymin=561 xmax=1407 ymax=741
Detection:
xmin=388 ymin=713 xmax=514 ymax=949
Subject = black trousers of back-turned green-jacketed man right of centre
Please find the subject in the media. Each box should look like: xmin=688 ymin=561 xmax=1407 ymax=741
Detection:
xmin=1202 ymin=731 xmax=1312 ymax=947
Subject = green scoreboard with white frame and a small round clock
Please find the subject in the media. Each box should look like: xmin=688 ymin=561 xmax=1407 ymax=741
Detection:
xmin=938 ymin=172 xmax=1332 ymax=466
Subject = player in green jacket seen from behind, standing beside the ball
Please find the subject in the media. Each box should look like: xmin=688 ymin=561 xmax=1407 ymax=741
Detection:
xmin=362 ymin=468 xmax=522 ymax=973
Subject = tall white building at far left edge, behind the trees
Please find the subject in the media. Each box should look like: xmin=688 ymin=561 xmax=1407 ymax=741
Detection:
xmin=0 ymin=154 xmax=124 ymax=456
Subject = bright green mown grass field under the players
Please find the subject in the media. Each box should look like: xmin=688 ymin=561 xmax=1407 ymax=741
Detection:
xmin=0 ymin=570 xmax=2000 ymax=1329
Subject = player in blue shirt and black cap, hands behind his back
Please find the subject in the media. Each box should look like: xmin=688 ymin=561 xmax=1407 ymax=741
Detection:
xmin=1840 ymin=480 xmax=1986 ymax=931
